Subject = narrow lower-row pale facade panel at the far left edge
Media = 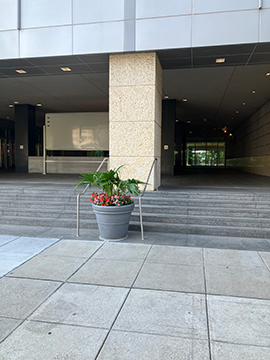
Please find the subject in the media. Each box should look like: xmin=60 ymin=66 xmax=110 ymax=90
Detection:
xmin=0 ymin=30 xmax=19 ymax=59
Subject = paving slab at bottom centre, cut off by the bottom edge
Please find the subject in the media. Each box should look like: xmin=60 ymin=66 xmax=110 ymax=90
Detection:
xmin=98 ymin=331 xmax=210 ymax=360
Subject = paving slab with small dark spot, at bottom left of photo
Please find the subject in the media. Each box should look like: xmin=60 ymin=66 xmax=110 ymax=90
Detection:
xmin=0 ymin=321 xmax=107 ymax=360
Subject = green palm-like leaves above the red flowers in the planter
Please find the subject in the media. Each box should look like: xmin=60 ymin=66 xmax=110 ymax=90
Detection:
xmin=75 ymin=165 xmax=145 ymax=201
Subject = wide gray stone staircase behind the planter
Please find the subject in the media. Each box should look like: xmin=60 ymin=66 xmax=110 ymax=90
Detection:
xmin=0 ymin=186 xmax=270 ymax=239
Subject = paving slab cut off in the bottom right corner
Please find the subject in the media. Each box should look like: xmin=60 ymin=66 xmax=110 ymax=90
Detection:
xmin=211 ymin=341 xmax=270 ymax=360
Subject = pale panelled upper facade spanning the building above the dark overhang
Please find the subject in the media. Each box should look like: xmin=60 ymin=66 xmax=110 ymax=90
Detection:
xmin=0 ymin=0 xmax=270 ymax=59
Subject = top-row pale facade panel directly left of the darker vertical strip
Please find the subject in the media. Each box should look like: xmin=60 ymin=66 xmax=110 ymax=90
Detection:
xmin=73 ymin=0 xmax=124 ymax=24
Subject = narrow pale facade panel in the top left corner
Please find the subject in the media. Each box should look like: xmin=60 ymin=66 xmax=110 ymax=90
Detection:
xmin=0 ymin=0 xmax=18 ymax=30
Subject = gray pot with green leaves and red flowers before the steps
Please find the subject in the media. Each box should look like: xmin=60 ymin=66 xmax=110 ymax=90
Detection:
xmin=75 ymin=165 xmax=145 ymax=240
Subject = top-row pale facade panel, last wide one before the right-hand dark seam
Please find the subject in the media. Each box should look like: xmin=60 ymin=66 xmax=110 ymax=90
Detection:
xmin=193 ymin=0 xmax=259 ymax=14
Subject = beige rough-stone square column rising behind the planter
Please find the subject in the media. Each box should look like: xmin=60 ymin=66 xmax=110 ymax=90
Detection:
xmin=109 ymin=53 xmax=162 ymax=190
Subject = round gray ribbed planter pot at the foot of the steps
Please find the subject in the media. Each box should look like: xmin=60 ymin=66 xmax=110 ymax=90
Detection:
xmin=92 ymin=203 xmax=134 ymax=240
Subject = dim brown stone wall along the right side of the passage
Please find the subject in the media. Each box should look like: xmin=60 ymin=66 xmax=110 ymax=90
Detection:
xmin=226 ymin=101 xmax=270 ymax=176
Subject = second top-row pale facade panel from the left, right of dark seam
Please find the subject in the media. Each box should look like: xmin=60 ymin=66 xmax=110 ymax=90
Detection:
xmin=21 ymin=0 xmax=72 ymax=28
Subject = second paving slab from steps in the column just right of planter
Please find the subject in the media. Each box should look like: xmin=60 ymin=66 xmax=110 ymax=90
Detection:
xmin=134 ymin=263 xmax=205 ymax=293
